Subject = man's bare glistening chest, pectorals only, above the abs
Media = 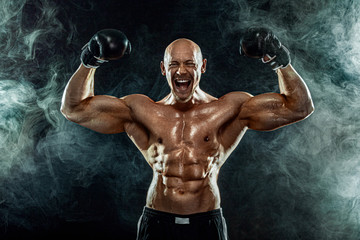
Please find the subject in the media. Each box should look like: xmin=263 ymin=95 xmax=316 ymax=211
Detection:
xmin=134 ymin=104 xmax=235 ymax=147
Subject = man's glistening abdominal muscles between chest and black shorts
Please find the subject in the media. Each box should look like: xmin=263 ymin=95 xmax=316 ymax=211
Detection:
xmin=146 ymin=145 xmax=220 ymax=214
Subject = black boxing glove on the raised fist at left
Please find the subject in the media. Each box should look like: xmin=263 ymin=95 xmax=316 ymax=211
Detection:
xmin=80 ymin=29 xmax=131 ymax=68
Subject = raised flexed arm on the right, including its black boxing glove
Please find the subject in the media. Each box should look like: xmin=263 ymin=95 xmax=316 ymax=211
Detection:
xmin=239 ymin=29 xmax=314 ymax=130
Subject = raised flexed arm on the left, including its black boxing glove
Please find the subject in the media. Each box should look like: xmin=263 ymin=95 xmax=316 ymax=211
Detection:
xmin=61 ymin=30 xmax=131 ymax=133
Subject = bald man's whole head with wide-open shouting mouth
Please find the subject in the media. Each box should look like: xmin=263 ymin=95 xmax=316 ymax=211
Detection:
xmin=161 ymin=41 xmax=206 ymax=102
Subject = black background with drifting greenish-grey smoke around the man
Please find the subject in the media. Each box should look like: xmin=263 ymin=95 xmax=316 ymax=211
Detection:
xmin=0 ymin=0 xmax=360 ymax=240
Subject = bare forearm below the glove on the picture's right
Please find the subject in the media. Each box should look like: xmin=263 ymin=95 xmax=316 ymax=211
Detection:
xmin=276 ymin=64 xmax=314 ymax=116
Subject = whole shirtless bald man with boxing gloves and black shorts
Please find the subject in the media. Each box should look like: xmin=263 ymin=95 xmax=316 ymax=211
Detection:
xmin=61 ymin=29 xmax=313 ymax=240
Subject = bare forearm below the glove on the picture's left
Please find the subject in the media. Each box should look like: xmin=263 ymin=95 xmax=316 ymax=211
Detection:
xmin=61 ymin=64 xmax=95 ymax=114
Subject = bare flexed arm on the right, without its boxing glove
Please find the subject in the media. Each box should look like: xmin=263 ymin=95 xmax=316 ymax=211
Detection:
xmin=239 ymin=65 xmax=314 ymax=130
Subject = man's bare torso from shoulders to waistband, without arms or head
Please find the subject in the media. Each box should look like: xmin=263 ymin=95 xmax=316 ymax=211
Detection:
xmin=125 ymin=91 xmax=247 ymax=214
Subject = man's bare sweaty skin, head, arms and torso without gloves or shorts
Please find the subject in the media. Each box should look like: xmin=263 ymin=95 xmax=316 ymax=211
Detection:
xmin=61 ymin=39 xmax=313 ymax=214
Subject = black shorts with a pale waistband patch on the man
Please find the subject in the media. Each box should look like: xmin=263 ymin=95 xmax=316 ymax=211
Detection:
xmin=136 ymin=207 xmax=228 ymax=240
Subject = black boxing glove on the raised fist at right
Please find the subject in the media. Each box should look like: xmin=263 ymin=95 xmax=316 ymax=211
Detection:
xmin=239 ymin=28 xmax=291 ymax=70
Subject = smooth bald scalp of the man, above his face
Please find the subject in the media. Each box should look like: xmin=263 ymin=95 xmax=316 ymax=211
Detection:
xmin=164 ymin=38 xmax=203 ymax=62
